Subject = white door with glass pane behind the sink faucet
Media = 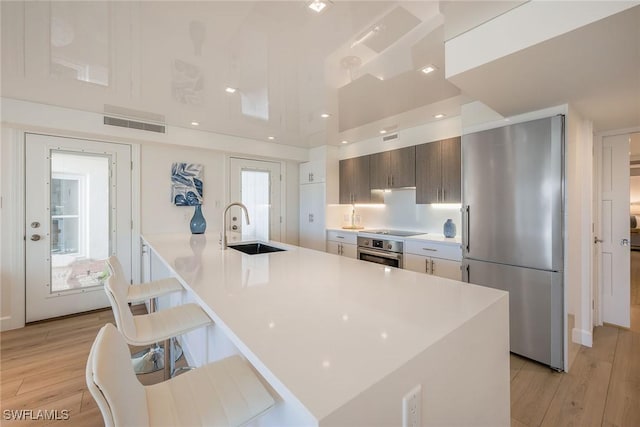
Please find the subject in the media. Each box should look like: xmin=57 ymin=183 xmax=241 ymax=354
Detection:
xmin=227 ymin=157 xmax=282 ymax=242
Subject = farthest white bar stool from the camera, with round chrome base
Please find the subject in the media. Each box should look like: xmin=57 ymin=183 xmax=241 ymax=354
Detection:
xmin=106 ymin=256 xmax=184 ymax=374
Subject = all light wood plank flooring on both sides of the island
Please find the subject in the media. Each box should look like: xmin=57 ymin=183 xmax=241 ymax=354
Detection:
xmin=0 ymin=311 xmax=640 ymax=427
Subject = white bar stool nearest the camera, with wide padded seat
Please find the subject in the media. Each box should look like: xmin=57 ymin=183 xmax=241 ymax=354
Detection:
xmin=86 ymin=323 xmax=275 ymax=427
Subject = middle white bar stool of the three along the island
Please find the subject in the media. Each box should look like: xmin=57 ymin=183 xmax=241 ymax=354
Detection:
xmin=104 ymin=270 xmax=212 ymax=379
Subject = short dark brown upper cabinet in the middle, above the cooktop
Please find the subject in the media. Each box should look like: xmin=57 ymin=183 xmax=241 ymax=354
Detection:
xmin=369 ymin=146 xmax=416 ymax=190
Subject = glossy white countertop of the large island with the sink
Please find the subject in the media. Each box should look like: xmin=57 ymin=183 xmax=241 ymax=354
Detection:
xmin=144 ymin=234 xmax=507 ymax=420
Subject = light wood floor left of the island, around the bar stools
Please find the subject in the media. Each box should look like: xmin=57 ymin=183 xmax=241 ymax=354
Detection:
xmin=0 ymin=305 xmax=168 ymax=427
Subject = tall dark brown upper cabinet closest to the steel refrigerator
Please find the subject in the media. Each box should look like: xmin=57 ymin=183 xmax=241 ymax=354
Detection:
xmin=416 ymin=137 xmax=462 ymax=204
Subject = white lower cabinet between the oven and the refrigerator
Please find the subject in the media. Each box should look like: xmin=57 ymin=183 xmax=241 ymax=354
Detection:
xmin=403 ymin=240 xmax=462 ymax=280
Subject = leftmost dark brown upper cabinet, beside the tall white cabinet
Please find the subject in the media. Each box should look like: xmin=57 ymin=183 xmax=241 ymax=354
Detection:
xmin=340 ymin=156 xmax=383 ymax=204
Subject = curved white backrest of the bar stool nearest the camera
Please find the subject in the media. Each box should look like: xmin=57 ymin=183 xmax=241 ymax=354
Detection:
xmin=86 ymin=323 xmax=149 ymax=427
